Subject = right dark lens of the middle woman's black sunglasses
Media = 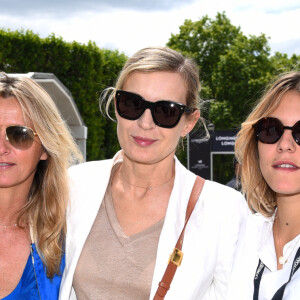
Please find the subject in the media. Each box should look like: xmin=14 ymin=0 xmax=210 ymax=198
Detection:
xmin=153 ymin=101 xmax=181 ymax=128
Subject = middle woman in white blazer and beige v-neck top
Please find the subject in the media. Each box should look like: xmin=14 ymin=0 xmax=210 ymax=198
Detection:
xmin=60 ymin=47 xmax=248 ymax=300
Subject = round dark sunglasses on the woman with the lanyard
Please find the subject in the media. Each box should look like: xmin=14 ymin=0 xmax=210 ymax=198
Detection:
xmin=253 ymin=117 xmax=300 ymax=145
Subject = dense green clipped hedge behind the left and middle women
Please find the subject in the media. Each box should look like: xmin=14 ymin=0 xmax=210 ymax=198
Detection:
xmin=0 ymin=30 xmax=126 ymax=160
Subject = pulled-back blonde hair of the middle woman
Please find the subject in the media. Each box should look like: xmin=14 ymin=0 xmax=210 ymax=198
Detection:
xmin=100 ymin=47 xmax=201 ymax=115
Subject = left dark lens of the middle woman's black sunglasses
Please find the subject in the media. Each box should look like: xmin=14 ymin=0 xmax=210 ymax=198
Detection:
xmin=116 ymin=92 xmax=145 ymax=120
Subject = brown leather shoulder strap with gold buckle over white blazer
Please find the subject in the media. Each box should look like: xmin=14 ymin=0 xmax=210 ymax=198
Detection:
xmin=153 ymin=176 xmax=205 ymax=300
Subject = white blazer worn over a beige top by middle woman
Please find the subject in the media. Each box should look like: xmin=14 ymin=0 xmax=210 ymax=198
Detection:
xmin=59 ymin=153 xmax=248 ymax=300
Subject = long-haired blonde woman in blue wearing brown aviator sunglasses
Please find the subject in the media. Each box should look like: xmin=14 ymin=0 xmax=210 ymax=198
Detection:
xmin=0 ymin=73 xmax=81 ymax=300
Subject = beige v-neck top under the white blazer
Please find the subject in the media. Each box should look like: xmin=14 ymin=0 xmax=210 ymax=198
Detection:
xmin=73 ymin=170 xmax=163 ymax=300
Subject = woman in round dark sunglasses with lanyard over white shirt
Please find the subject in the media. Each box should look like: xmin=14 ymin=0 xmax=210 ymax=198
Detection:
xmin=228 ymin=72 xmax=300 ymax=300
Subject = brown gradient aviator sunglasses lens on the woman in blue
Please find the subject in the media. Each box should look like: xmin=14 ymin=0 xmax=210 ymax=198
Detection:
xmin=5 ymin=125 xmax=37 ymax=150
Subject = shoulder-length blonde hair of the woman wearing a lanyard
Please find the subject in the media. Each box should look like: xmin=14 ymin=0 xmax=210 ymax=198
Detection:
xmin=235 ymin=72 xmax=300 ymax=217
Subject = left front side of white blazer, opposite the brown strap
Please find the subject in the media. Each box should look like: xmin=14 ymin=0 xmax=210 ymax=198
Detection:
xmin=59 ymin=152 xmax=119 ymax=299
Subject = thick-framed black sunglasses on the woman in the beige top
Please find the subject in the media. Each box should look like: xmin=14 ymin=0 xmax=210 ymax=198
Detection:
xmin=116 ymin=90 xmax=195 ymax=128
